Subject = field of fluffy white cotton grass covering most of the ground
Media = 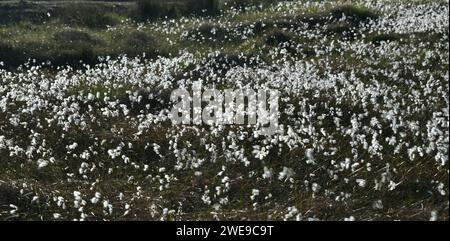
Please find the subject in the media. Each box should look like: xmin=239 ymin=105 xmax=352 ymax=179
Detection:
xmin=0 ymin=0 xmax=449 ymax=221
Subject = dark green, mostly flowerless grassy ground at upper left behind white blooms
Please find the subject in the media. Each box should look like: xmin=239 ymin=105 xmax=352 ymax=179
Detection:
xmin=0 ymin=0 xmax=294 ymax=68
